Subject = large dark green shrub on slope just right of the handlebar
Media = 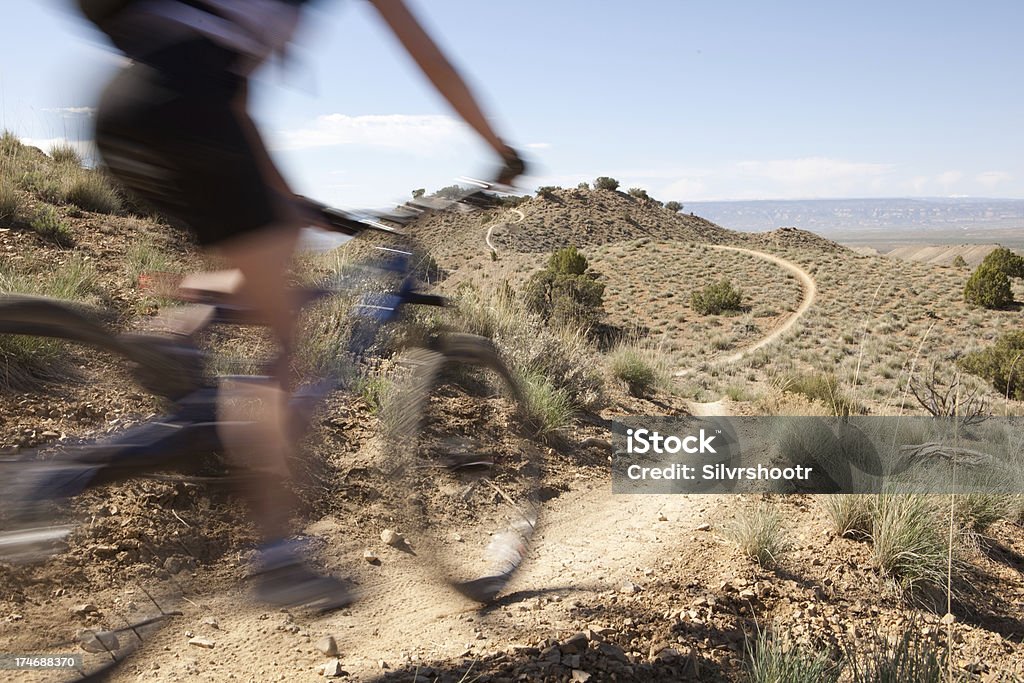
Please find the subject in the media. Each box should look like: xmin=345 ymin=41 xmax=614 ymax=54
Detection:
xmin=525 ymin=247 xmax=604 ymax=326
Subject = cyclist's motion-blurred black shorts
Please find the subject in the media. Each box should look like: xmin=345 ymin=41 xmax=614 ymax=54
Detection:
xmin=96 ymin=38 xmax=286 ymax=245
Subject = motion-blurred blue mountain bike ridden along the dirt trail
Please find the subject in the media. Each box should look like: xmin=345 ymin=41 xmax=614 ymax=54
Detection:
xmin=0 ymin=183 xmax=543 ymax=680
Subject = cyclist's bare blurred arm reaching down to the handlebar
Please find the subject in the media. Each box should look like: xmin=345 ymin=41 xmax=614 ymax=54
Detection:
xmin=371 ymin=0 xmax=517 ymax=160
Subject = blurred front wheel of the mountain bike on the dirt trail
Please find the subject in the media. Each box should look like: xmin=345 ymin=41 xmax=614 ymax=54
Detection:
xmin=382 ymin=335 xmax=543 ymax=602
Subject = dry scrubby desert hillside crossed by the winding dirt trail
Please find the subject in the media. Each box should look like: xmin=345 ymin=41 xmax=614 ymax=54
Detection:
xmin=0 ymin=145 xmax=1024 ymax=683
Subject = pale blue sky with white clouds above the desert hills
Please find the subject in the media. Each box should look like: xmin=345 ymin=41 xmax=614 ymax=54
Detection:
xmin=0 ymin=0 xmax=1024 ymax=206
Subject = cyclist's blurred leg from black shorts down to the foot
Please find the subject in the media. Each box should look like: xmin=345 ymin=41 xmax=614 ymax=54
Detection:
xmin=96 ymin=39 xmax=352 ymax=603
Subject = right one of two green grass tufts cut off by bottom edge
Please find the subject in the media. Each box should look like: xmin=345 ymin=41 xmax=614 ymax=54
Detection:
xmin=845 ymin=623 xmax=946 ymax=683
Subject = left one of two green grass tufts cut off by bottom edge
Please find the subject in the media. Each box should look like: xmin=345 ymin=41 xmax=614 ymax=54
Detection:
xmin=745 ymin=631 xmax=842 ymax=683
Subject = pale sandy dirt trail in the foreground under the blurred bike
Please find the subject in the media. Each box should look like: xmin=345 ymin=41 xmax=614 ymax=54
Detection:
xmin=116 ymin=479 xmax=720 ymax=681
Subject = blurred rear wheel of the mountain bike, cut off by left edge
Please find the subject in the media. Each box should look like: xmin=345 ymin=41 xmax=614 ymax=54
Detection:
xmin=0 ymin=295 xmax=190 ymax=681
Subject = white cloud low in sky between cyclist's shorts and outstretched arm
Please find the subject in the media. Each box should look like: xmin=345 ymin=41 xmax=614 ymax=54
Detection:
xmin=270 ymin=114 xmax=468 ymax=154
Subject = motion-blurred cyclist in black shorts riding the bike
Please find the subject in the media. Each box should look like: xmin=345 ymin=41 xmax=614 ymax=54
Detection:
xmin=79 ymin=0 xmax=523 ymax=608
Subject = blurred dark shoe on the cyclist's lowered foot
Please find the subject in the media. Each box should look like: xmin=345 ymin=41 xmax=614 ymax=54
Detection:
xmin=251 ymin=542 xmax=355 ymax=611
